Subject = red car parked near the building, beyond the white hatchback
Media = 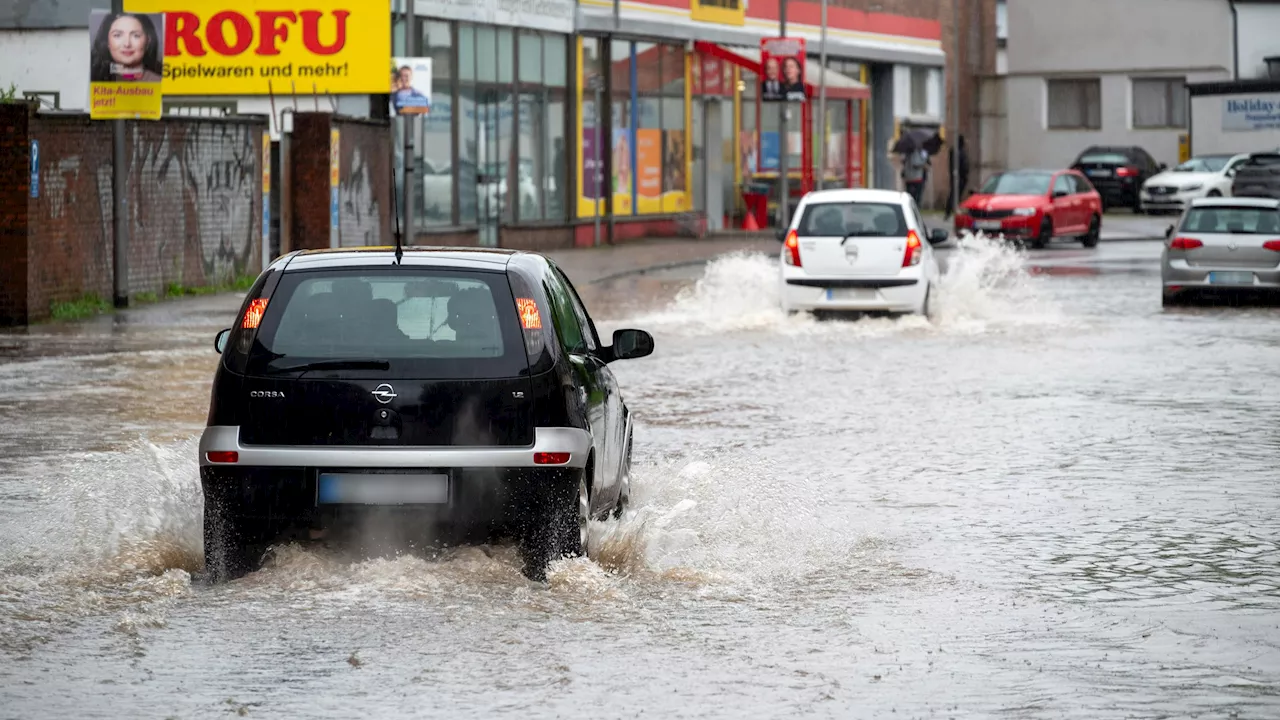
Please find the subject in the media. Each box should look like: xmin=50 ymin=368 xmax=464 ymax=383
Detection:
xmin=955 ymin=170 xmax=1102 ymax=247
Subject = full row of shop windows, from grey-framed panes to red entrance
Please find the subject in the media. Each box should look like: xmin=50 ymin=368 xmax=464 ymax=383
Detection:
xmin=393 ymin=18 xmax=865 ymax=234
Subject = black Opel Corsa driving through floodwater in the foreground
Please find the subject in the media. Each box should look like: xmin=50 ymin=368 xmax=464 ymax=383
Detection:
xmin=200 ymin=247 xmax=653 ymax=582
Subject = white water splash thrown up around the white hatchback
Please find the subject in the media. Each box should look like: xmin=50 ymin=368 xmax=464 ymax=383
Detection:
xmin=626 ymin=233 xmax=1066 ymax=336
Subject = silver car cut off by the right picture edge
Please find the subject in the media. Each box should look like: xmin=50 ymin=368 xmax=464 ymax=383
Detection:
xmin=1161 ymin=197 xmax=1280 ymax=305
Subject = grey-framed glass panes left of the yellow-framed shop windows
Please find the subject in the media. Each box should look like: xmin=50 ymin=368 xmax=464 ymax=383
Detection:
xmin=393 ymin=18 xmax=570 ymax=233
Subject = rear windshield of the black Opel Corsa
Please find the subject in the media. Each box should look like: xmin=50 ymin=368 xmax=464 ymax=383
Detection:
xmin=248 ymin=266 xmax=527 ymax=378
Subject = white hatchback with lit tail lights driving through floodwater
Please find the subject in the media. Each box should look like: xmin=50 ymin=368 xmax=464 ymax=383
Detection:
xmin=778 ymin=188 xmax=947 ymax=315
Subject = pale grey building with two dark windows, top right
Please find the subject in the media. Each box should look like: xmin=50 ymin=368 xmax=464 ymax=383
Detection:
xmin=1005 ymin=0 xmax=1280 ymax=168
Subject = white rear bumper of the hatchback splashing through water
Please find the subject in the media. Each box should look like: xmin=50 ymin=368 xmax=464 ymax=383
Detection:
xmin=781 ymin=275 xmax=928 ymax=313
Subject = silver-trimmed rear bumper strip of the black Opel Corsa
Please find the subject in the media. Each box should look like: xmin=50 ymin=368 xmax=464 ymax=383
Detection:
xmin=200 ymin=425 xmax=591 ymax=469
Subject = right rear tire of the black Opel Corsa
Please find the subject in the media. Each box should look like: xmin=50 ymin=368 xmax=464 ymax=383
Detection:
xmin=520 ymin=468 xmax=591 ymax=583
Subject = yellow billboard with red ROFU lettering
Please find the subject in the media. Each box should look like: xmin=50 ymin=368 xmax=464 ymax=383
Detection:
xmin=124 ymin=0 xmax=392 ymax=95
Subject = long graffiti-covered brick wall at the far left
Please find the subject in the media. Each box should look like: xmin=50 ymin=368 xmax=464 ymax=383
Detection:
xmin=0 ymin=105 xmax=266 ymax=324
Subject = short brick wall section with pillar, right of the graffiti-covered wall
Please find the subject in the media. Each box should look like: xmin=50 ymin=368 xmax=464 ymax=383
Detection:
xmin=287 ymin=113 xmax=394 ymax=250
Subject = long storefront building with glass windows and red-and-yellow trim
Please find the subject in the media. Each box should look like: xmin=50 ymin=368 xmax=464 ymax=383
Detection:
xmin=393 ymin=0 xmax=943 ymax=249
